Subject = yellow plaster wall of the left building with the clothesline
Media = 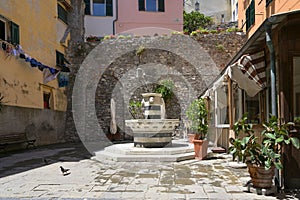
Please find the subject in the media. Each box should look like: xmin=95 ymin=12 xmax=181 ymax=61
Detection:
xmin=0 ymin=0 xmax=67 ymax=111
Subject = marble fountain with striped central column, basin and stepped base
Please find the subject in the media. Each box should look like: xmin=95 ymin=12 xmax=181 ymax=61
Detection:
xmin=95 ymin=93 xmax=194 ymax=162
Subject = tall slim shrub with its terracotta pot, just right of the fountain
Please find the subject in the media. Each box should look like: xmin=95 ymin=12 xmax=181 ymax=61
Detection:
xmin=186 ymin=98 xmax=208 ymax=160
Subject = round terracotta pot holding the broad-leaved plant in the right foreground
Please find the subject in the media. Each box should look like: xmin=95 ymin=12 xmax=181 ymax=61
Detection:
xmin=247 ymin=164 xmax=275 ymax=188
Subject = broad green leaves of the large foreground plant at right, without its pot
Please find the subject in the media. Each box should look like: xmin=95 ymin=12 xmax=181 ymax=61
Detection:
xmin=229 ymin=115 xmax=300 ymax=169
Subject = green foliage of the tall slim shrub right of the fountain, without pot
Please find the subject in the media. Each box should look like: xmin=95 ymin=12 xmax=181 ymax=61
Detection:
xmin=186 ymin=98 xmax=208 ymax=140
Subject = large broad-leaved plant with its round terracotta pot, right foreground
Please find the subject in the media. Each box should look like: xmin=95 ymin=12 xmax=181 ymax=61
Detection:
xmin=229 ymin=115 xmax=299 ymax=188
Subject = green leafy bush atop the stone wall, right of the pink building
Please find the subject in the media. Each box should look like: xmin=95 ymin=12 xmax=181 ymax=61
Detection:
xmin=183 ymin=11 xmax=212 ymax=33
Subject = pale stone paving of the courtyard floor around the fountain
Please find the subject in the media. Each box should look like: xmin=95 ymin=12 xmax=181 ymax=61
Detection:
xmin=0 ymin=141 xmax=300 ymax=199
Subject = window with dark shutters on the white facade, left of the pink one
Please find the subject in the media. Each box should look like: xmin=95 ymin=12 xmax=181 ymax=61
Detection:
xmin=84 ymin=0 xmax=113 ymax=16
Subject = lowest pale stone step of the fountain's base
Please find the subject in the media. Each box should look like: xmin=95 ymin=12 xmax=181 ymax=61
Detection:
xmin=94 ymin=150 xmax=195 ymax=162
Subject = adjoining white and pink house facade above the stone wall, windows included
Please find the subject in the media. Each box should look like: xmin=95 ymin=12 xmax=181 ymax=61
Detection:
xmin=85 ymin=0 xmax=183 ymax=37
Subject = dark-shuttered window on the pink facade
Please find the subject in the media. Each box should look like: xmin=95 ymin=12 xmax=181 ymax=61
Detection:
xmin=139 ymin=0 xmax=165 ymax=12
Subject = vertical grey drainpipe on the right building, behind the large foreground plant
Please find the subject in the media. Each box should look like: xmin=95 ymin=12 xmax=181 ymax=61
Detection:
xmin=266 ymin=18 xmax=281 ymax=192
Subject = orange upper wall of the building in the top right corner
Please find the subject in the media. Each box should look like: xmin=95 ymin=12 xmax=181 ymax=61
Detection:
xmin=238 ymin=0 xmax=300 ymax=38
